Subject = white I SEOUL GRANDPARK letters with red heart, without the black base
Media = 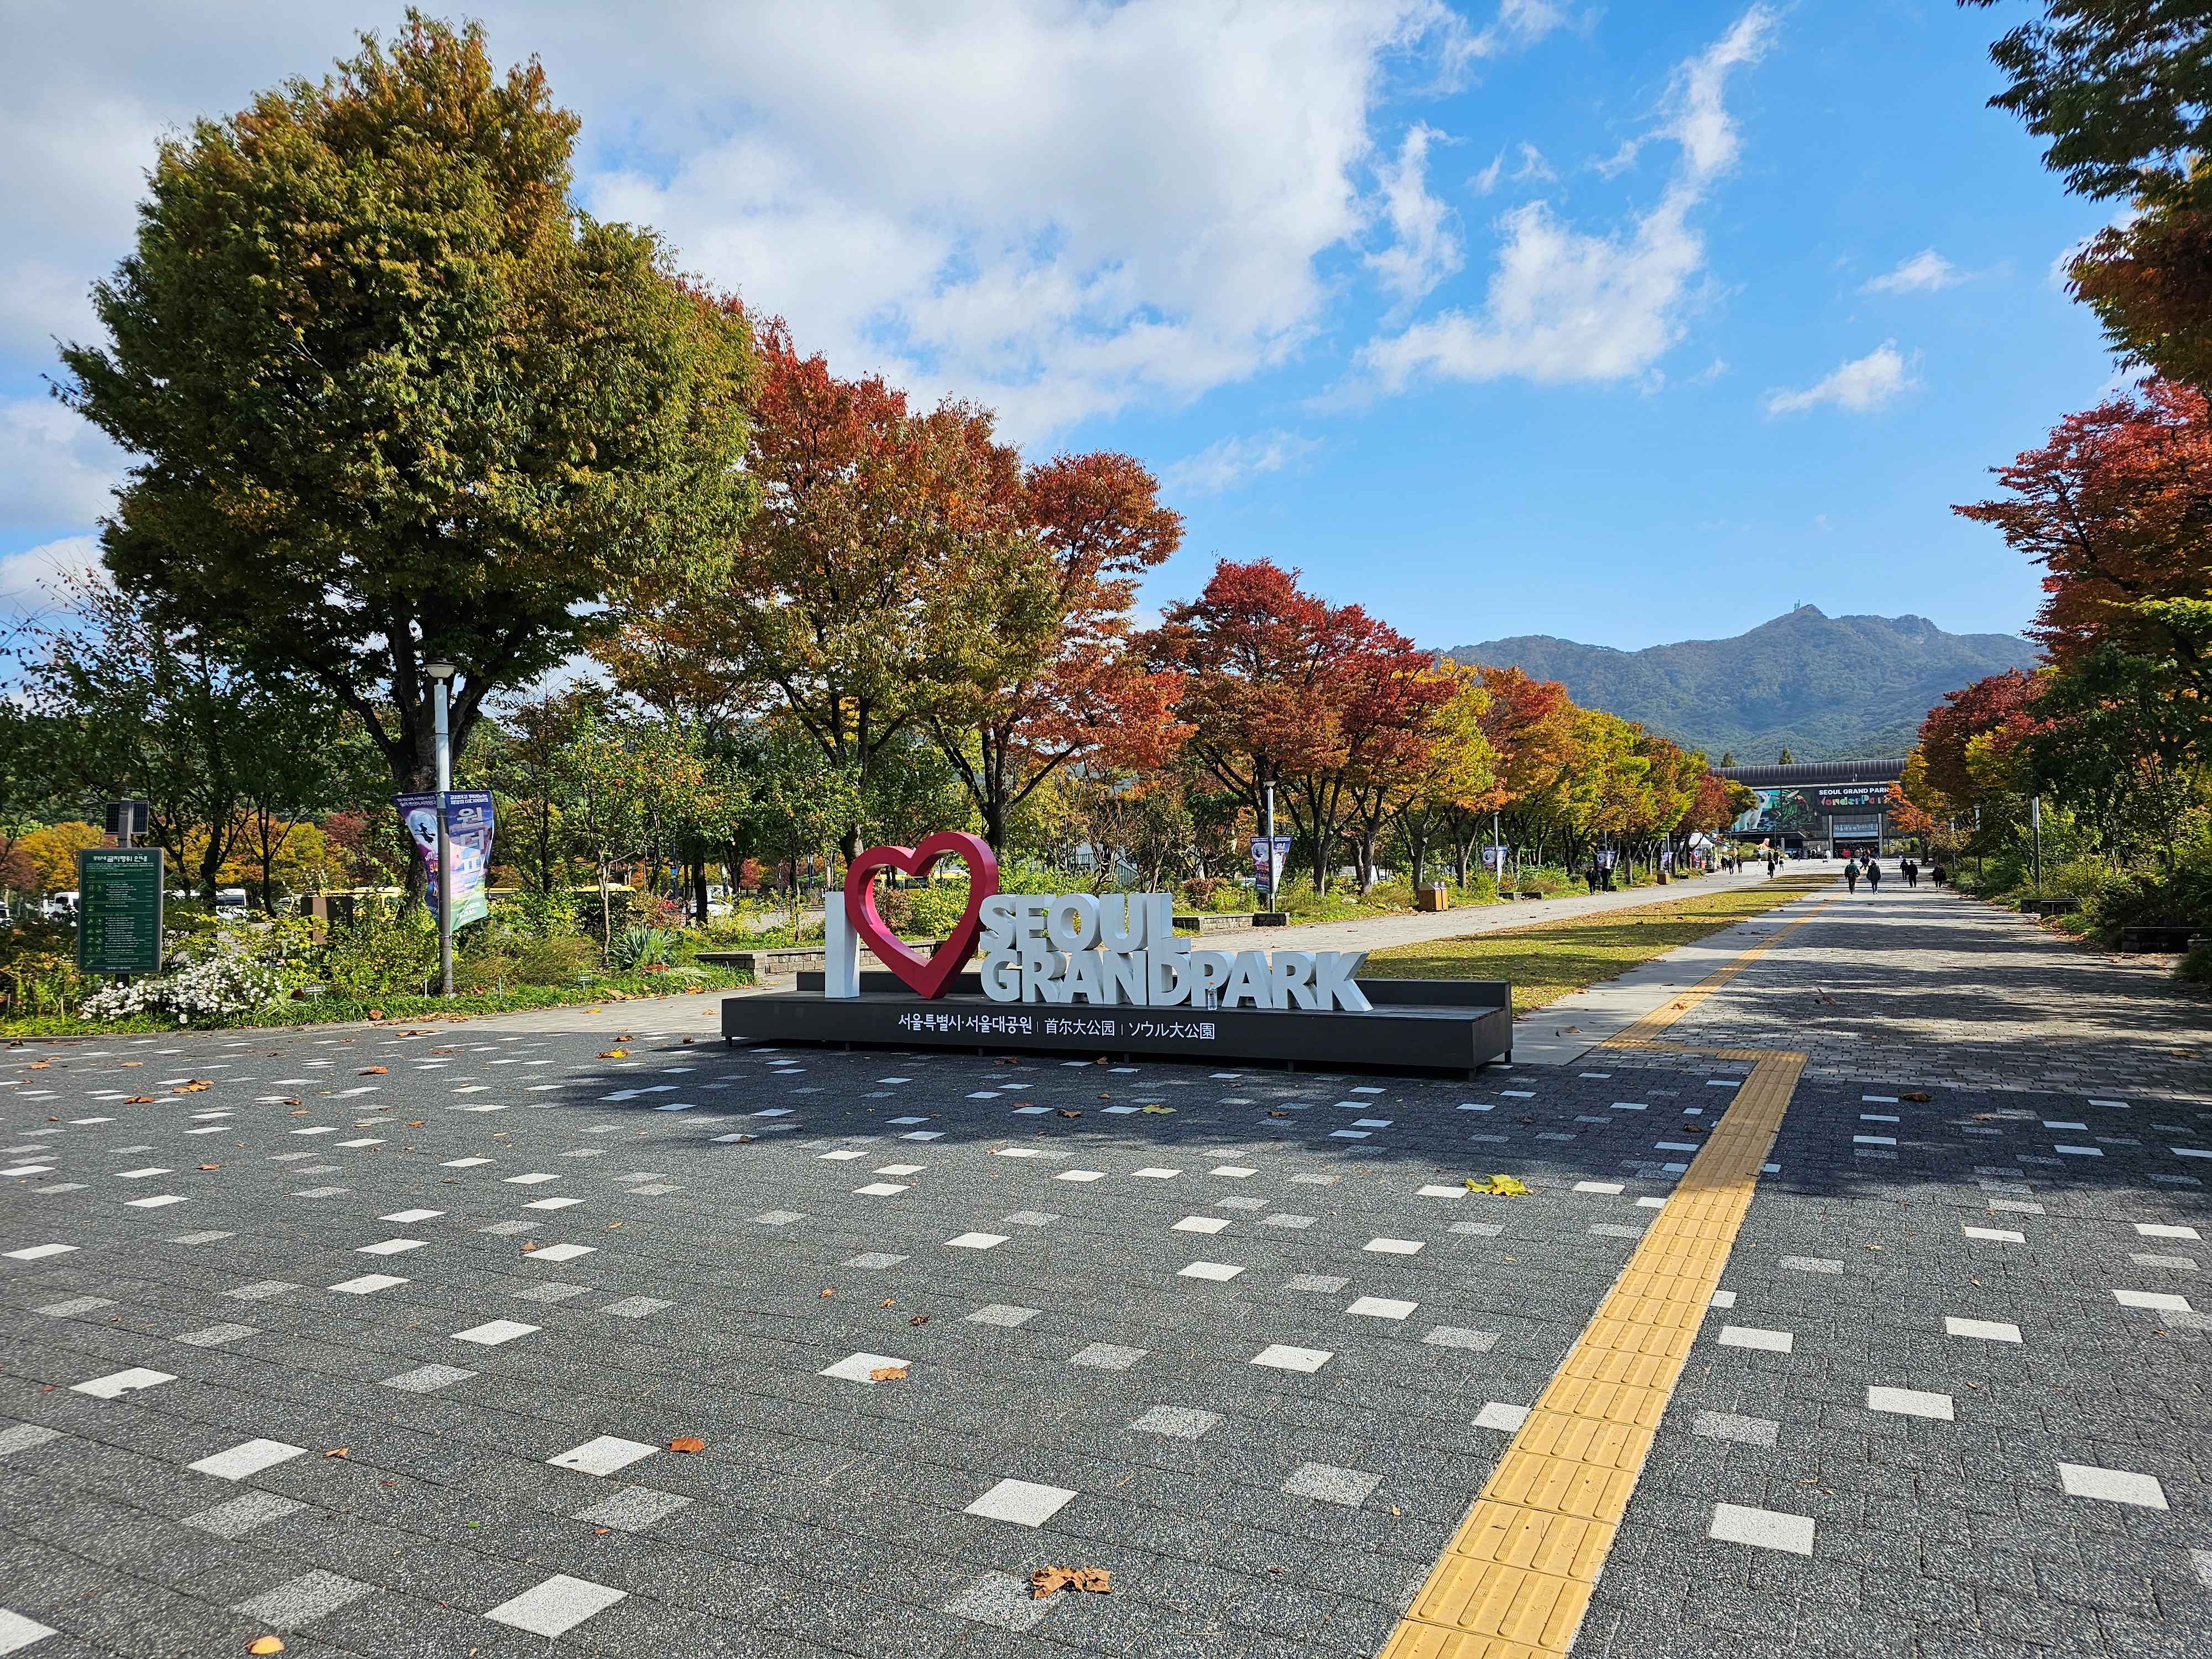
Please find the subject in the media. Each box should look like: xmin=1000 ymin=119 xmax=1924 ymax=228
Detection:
xmin=823 ymin=832 xmax=1371 ymax=1013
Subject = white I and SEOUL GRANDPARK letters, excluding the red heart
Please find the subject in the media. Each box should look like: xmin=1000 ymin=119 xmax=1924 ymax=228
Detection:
xmin=825 ymin=894 xmax=1371 ymax=1013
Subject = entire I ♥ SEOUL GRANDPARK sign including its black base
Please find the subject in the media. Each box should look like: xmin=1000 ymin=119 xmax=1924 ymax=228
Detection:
xmin=721 ymin=832 xmax=1513 ymax=1073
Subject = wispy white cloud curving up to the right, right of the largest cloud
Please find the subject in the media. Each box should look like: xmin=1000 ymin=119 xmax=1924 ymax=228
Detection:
xmin=1360 ymin=4 xmax=1774 ymax=392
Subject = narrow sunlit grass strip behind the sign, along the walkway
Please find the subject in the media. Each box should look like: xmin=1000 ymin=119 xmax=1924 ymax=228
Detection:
xmin=1360 ymin=880 xmax=1829 ymax=1013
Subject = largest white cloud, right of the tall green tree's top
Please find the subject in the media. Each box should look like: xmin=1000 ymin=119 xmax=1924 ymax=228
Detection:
xmin=580 ymin=0 xmax=1464 ymax=436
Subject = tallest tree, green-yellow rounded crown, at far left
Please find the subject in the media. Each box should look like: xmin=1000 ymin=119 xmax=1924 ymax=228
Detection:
xmin=62 ymin=13 xmax=752 ymax=805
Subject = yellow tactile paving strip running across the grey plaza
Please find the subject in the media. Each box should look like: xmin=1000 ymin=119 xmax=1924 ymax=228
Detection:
xmin=1383 ymin=916 xmax=1812 ymax=1659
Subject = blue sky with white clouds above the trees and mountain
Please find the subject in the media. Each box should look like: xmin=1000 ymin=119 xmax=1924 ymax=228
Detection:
xmin=0 ymin=0 xmax=2112 ymax=648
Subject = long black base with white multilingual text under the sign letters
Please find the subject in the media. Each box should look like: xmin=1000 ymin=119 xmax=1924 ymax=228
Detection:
xmin=721 ymin=973 xmax=1513 ymax=1075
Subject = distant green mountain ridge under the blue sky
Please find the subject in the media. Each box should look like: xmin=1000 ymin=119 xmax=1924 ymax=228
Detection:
xmin=1442 ymin=604 xmax=2037 ymax=765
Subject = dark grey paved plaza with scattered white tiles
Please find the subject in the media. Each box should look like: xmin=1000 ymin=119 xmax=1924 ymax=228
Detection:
xmin=0 ymin=889 xmax=2212 ymax=1659
